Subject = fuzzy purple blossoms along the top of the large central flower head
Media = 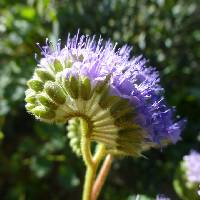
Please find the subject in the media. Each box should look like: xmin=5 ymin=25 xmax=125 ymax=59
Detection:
xmin=38 ymin=34 xmax=185 ymax=145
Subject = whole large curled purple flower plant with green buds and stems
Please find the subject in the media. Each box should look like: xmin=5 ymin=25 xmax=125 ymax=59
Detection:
xmin=25 ymin=34 xmax=184 ymax=200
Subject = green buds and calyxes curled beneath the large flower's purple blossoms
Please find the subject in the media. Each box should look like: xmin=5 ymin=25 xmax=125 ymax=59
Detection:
xmin=25 ymin=58 xmax=145 ymax=156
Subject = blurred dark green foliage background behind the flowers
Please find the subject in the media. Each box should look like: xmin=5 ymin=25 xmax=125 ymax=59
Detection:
xmin=0 ymin=0 xmax=200 ymax=200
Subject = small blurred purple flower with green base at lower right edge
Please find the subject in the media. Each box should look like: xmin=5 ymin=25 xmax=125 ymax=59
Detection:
xmin=174 ymin=150 xmax=200 ymax=200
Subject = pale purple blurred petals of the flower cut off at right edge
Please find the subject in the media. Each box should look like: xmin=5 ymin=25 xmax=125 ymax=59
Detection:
xmin=183 ymin=150 xmax=200 ymax=183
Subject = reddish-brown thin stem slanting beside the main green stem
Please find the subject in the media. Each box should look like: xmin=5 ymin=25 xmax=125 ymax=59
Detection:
xmin=91 ymin=154 xmax=113 ymax=200
